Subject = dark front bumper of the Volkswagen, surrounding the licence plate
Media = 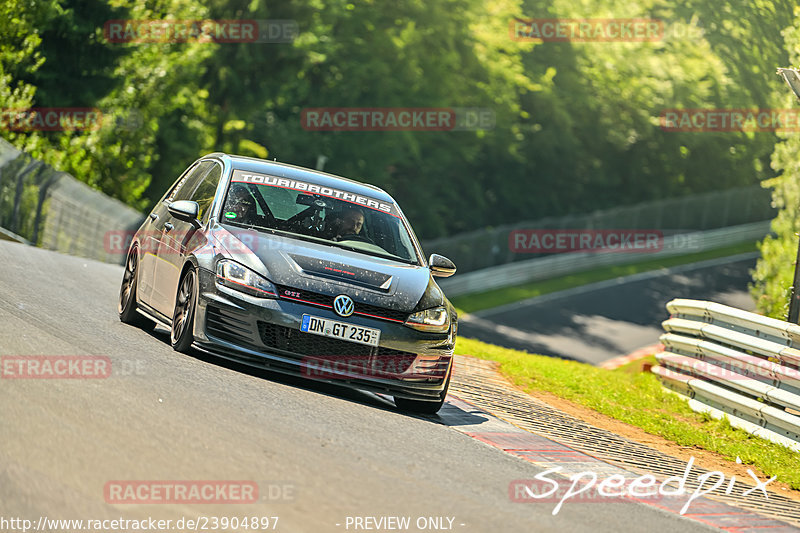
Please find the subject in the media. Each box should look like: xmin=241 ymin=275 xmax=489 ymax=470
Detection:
xmin=187 ymin=269 xmax=455 ymax=401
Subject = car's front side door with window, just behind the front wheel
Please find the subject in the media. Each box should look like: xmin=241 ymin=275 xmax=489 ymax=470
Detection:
xmin=155 ymin=161 xmax=222 ymax=317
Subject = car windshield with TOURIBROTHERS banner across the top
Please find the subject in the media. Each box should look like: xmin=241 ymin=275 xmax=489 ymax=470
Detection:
xmin=221 ymin=170 xmax=418 ymax=264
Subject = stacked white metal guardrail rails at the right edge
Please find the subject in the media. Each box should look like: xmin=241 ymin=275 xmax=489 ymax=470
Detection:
xmin=652 ymin=299 xmax=800 ymax=451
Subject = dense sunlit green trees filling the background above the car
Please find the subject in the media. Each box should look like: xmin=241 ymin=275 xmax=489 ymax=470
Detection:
xmin=0 ymin=0 xmax=793 ymax=238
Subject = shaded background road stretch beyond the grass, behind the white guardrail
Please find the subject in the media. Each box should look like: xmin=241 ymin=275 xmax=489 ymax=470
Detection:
xmin=458 ymin=254 xmax=756 ymax=364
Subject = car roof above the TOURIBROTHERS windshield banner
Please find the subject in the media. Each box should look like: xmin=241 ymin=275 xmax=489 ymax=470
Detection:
xmin=204 ymin=152 xmax=396 ymax=203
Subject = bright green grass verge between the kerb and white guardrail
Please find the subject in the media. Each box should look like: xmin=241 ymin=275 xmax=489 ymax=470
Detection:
xmin=456 ymin=338 xmax=800 ymax=489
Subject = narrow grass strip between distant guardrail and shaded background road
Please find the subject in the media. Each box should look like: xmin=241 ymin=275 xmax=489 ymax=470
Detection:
xmin=451 ymin=242 xmax=756 ymax=313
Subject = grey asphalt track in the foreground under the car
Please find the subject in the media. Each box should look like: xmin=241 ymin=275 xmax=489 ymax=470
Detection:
xmin=0 ymin=242 xmax=720 ymax=532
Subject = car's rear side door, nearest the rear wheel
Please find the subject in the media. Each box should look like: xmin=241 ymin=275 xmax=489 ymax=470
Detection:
xmin=136 ymin=162 xmax=200 ymax=307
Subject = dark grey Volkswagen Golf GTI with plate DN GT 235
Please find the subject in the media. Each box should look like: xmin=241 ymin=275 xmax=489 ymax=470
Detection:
xmin=119 ymin=153 xmax=457 ymax=413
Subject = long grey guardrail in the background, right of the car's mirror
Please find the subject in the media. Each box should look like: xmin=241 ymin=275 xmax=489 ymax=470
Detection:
xmin=438 ymin=220 xmax=770 ymax=297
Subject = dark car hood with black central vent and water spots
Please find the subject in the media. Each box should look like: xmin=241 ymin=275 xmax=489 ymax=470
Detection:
xmin=212 ymin=224 xmax=444 ymax=313
